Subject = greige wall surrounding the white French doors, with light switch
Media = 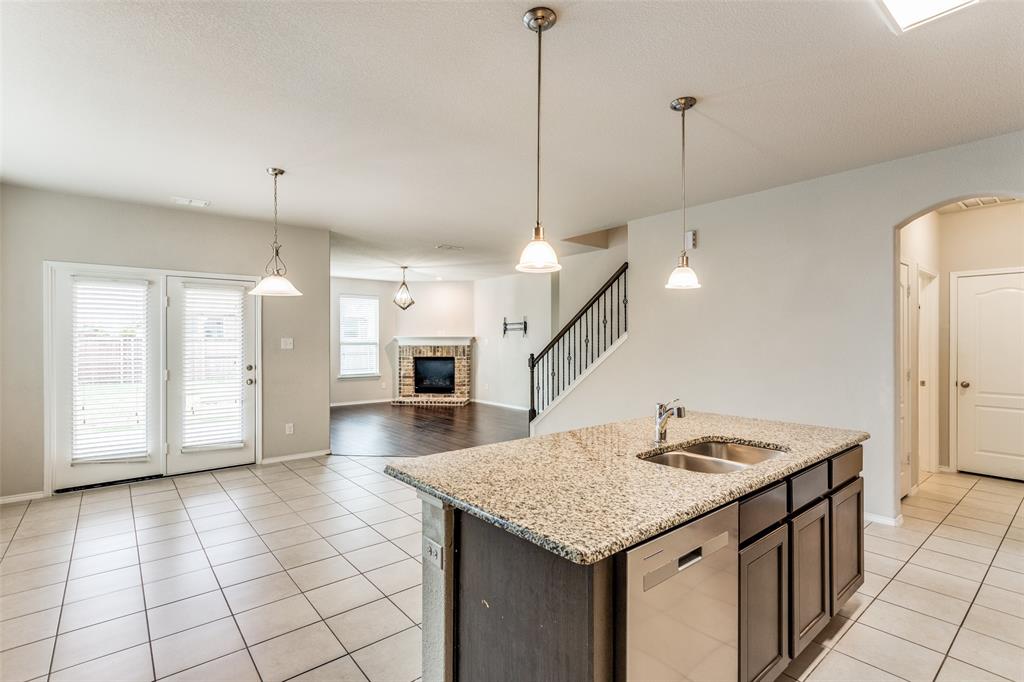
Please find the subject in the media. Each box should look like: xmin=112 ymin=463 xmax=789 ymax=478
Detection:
xmin=0 ymin=184 xmax=330 ymax=496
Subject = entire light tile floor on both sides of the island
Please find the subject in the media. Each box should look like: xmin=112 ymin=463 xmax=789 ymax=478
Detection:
xmin=0 ymin=457 xmax=1024 ymax=682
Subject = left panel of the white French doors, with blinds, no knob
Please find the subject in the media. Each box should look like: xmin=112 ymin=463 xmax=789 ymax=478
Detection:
xmin=46 ymin=265 xmax=163 ymax=491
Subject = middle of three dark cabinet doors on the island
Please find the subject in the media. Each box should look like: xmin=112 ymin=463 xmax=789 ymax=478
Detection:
xmin=790 ymin=500 xmax=831 ymax=657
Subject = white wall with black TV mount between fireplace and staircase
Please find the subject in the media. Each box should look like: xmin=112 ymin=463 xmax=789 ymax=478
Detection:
xmin=473 ymin=274 xmax=551 ymax=409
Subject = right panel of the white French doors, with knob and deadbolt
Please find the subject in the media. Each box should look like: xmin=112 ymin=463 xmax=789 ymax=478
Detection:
xmin=166 ymin=276 xmax=256 ymax=474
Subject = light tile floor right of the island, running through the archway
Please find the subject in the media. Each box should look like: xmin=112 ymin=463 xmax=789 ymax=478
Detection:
xmin=781 ymin=473 xmax=1024 ymax=682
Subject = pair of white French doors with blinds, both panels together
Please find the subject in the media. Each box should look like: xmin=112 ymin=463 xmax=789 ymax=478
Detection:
xmin=50 ymin=263 xmax=258 ymax=491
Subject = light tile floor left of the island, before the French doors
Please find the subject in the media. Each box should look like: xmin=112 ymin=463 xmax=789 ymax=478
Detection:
xmin=0 ymin=457 xmax=422 ymax=682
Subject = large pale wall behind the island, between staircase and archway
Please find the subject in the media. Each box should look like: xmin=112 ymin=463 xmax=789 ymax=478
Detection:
xmin=540 ymin=132 xmax=1024 ymax=517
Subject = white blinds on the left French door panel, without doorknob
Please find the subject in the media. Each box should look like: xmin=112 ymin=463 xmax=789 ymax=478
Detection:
xmin=71 ymin=278 xmax=151 ymax=463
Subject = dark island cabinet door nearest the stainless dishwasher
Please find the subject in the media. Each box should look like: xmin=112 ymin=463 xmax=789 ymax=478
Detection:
xmin=739 ymin=525 xmax=790 ymax=682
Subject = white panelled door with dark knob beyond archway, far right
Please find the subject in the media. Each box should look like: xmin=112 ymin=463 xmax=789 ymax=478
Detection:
xmin=952 ymin=271 xmax=1024 ymax=479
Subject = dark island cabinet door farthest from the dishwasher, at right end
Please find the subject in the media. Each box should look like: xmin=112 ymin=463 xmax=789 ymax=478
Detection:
xmin=828 ymin=478 xmax=864 ymax=613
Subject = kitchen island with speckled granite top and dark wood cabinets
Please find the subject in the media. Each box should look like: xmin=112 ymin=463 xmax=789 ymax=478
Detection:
xmin=386 ymin=413 xmax=868 ymax=681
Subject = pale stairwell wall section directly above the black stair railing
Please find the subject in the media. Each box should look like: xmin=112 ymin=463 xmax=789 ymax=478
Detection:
xmin=553 ymin=226 xmax=629 ymax=332
